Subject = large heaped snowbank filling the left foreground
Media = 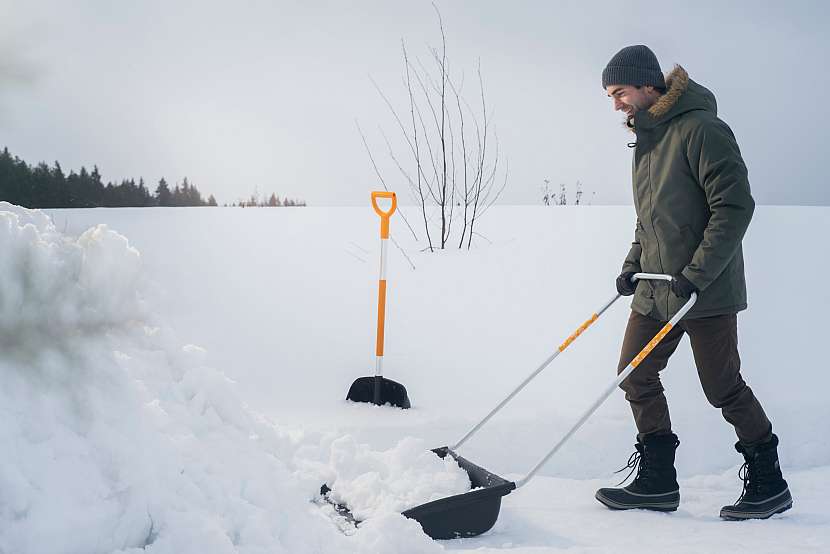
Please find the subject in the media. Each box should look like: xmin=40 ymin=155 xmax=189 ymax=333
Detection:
xmin=0 ymin=204 xmax=442 ymax=554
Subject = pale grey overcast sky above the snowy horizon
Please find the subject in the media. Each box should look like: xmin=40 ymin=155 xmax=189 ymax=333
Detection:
xmin=0 ymin=0 xmax=830 ymax=205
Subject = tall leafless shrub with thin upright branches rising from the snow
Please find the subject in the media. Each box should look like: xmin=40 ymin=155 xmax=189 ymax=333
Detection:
xmin=358 ymin=4 xmax=508 ymax=251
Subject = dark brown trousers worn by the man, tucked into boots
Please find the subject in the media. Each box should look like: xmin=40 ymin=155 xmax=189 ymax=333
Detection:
xmin=617 ymin=312 xmax=772 ymax=444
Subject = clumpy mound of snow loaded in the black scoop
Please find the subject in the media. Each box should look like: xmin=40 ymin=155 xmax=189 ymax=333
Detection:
xmin=328 ymin=435 xmax=470 ymax=520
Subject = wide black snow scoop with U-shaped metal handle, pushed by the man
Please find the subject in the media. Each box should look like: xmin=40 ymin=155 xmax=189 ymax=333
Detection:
xmin=320 ymin=273 xmax=697 ymax=539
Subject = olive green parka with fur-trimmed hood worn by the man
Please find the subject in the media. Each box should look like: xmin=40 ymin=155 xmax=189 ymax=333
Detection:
xmin=622 ymin=66 xmax=755 ymax=321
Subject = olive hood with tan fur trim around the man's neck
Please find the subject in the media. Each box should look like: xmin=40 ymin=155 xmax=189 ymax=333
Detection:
xmin=626 ymin=65 xmax=718 ymax=129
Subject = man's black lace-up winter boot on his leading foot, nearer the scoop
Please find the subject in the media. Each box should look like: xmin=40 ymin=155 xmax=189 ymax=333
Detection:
xmin=596 ymin=433 xmax=680 ymax=512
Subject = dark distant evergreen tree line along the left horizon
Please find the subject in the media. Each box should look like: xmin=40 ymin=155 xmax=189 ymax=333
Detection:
xmin=0 ymin=147 xmax=305 ymax=208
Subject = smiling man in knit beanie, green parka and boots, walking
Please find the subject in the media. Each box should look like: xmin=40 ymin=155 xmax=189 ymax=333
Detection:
xmin=596 ymin=45 xmax=793 ymax=519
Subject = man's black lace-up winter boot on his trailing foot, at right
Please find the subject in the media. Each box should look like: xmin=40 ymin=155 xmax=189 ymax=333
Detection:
xmin=720 ymin=435 xmax=793 ymax=520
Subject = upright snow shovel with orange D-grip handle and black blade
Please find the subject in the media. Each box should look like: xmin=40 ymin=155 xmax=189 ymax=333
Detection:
xmin=346 ymin=191 xmax=410 ymax=408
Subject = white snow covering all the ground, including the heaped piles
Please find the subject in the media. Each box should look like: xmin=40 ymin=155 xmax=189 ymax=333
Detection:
xmin=0 ymin=204 xmax=830 ymax=553
